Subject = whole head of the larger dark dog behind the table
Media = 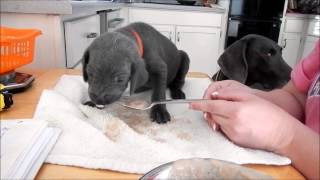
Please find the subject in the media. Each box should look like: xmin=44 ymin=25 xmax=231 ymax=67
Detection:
xmin=218 ymin=34 xmax=291 ymax=89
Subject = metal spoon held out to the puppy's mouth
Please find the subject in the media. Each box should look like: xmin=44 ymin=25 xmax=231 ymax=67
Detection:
xmin=118 ymin=99 xmax=210 ymax=111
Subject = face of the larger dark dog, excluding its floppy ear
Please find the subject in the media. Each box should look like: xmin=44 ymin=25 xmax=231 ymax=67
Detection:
xmin=246 ymin=35 xmax=291 ymax=89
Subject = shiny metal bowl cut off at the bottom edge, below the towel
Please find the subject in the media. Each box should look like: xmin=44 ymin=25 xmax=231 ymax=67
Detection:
xmin=140 ymin=158 xmax=273 ymax=180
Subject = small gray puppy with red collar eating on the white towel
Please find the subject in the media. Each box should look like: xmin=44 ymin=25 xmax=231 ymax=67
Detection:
xmin=82 ymin=22 xmax=190 ymax=123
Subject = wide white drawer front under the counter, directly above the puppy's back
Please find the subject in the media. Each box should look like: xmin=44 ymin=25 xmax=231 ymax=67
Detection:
xmin=129 ymin=8 xmax=222 ymax=27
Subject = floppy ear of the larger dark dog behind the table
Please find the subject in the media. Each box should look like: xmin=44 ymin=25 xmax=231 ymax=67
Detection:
xmin=218 ymin=38 xmax=249 ymax=83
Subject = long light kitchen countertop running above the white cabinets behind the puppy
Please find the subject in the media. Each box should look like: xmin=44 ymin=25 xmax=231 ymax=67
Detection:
xmin=1 ymin=0 xmax=226 ymax=16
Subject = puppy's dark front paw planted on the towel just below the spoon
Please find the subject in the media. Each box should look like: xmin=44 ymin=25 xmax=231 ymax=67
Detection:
xmin=150 ymin=105 xmax=170 ymax=124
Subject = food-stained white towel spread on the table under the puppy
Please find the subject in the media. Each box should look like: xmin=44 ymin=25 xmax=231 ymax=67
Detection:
xmin=34 ymin=75 xmax=291 ymax=173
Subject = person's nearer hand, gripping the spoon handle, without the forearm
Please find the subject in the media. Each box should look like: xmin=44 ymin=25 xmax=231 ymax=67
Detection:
xmin=190 ymin=89 xmax=297 ymax=151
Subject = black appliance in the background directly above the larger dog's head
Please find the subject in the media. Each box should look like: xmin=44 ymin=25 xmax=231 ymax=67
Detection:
xmin=226 ymin=0 xmax=285 ymax=47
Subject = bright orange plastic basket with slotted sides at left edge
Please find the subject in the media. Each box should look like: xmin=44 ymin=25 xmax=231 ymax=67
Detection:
xmin=0 ymin=27 xmax=41 ymax=74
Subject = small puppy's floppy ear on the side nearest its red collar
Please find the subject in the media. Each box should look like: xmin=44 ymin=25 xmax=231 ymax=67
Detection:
xmin=130 ymin=58 xmax=149 ymax=95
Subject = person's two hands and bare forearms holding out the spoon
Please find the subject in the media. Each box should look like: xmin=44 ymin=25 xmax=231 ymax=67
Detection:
xmin=191 ymin=81 xmax=320 ymax=179
